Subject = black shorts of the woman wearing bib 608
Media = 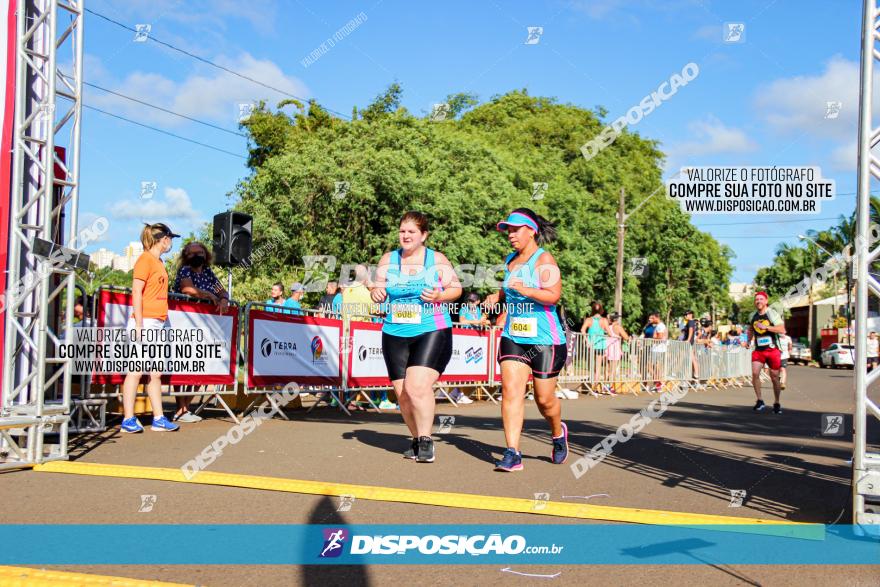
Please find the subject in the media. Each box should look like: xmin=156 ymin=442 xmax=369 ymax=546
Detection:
xmin=382 ymin=328 xmax=452 ymax=381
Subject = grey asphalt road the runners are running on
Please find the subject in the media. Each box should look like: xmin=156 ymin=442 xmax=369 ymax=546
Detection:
xmin=0 ymin=366 xmax=880 ymax=586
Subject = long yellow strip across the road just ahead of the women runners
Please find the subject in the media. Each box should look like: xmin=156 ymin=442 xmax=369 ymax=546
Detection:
xmin=34 ymin=461 xmax=825 ymax=540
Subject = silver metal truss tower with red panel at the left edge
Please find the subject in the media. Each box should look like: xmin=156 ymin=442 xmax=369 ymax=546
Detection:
xmin=0 ymin=0 xmax=83 ymax=469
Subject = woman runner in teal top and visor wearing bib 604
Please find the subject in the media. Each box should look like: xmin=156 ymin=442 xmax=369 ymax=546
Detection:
xmin=486 ymin=208 xmax=568 ymax=472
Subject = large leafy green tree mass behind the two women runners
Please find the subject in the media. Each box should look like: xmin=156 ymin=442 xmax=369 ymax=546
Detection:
xmin=235 ymin=84 xmax=733 ymax=328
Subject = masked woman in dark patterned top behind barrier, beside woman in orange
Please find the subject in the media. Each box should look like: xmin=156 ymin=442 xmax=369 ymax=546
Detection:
xmin=172 ymin=241 xmax=229 ymax=422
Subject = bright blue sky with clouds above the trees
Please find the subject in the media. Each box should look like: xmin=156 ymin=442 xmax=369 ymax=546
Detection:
xmin=80 ymin=0 xmax=861 ymax=281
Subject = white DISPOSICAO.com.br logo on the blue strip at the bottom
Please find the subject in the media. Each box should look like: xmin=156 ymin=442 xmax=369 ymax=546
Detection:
xmin=319 ymin=528 xmax=564 ymax=558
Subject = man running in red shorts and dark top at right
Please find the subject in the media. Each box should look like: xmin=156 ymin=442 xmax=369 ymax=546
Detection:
xmin=749 ymin=291 xmax=785 ymax=414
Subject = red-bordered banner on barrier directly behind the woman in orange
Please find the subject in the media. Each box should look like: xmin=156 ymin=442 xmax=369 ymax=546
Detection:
xmin=92 ymin=290 xmax=238 ymax=385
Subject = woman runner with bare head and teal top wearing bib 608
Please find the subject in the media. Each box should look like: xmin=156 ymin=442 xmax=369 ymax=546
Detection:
xmin=370 ymin=212 xmax=461 ymax=463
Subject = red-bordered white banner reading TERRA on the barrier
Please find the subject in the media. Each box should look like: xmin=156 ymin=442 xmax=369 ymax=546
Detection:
xmin=247 ymin=310 xmax=342 ymax=388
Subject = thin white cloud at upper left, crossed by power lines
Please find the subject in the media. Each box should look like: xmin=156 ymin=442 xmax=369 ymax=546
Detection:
xmin=89 ymin=53 xmax=309 ymax=128
